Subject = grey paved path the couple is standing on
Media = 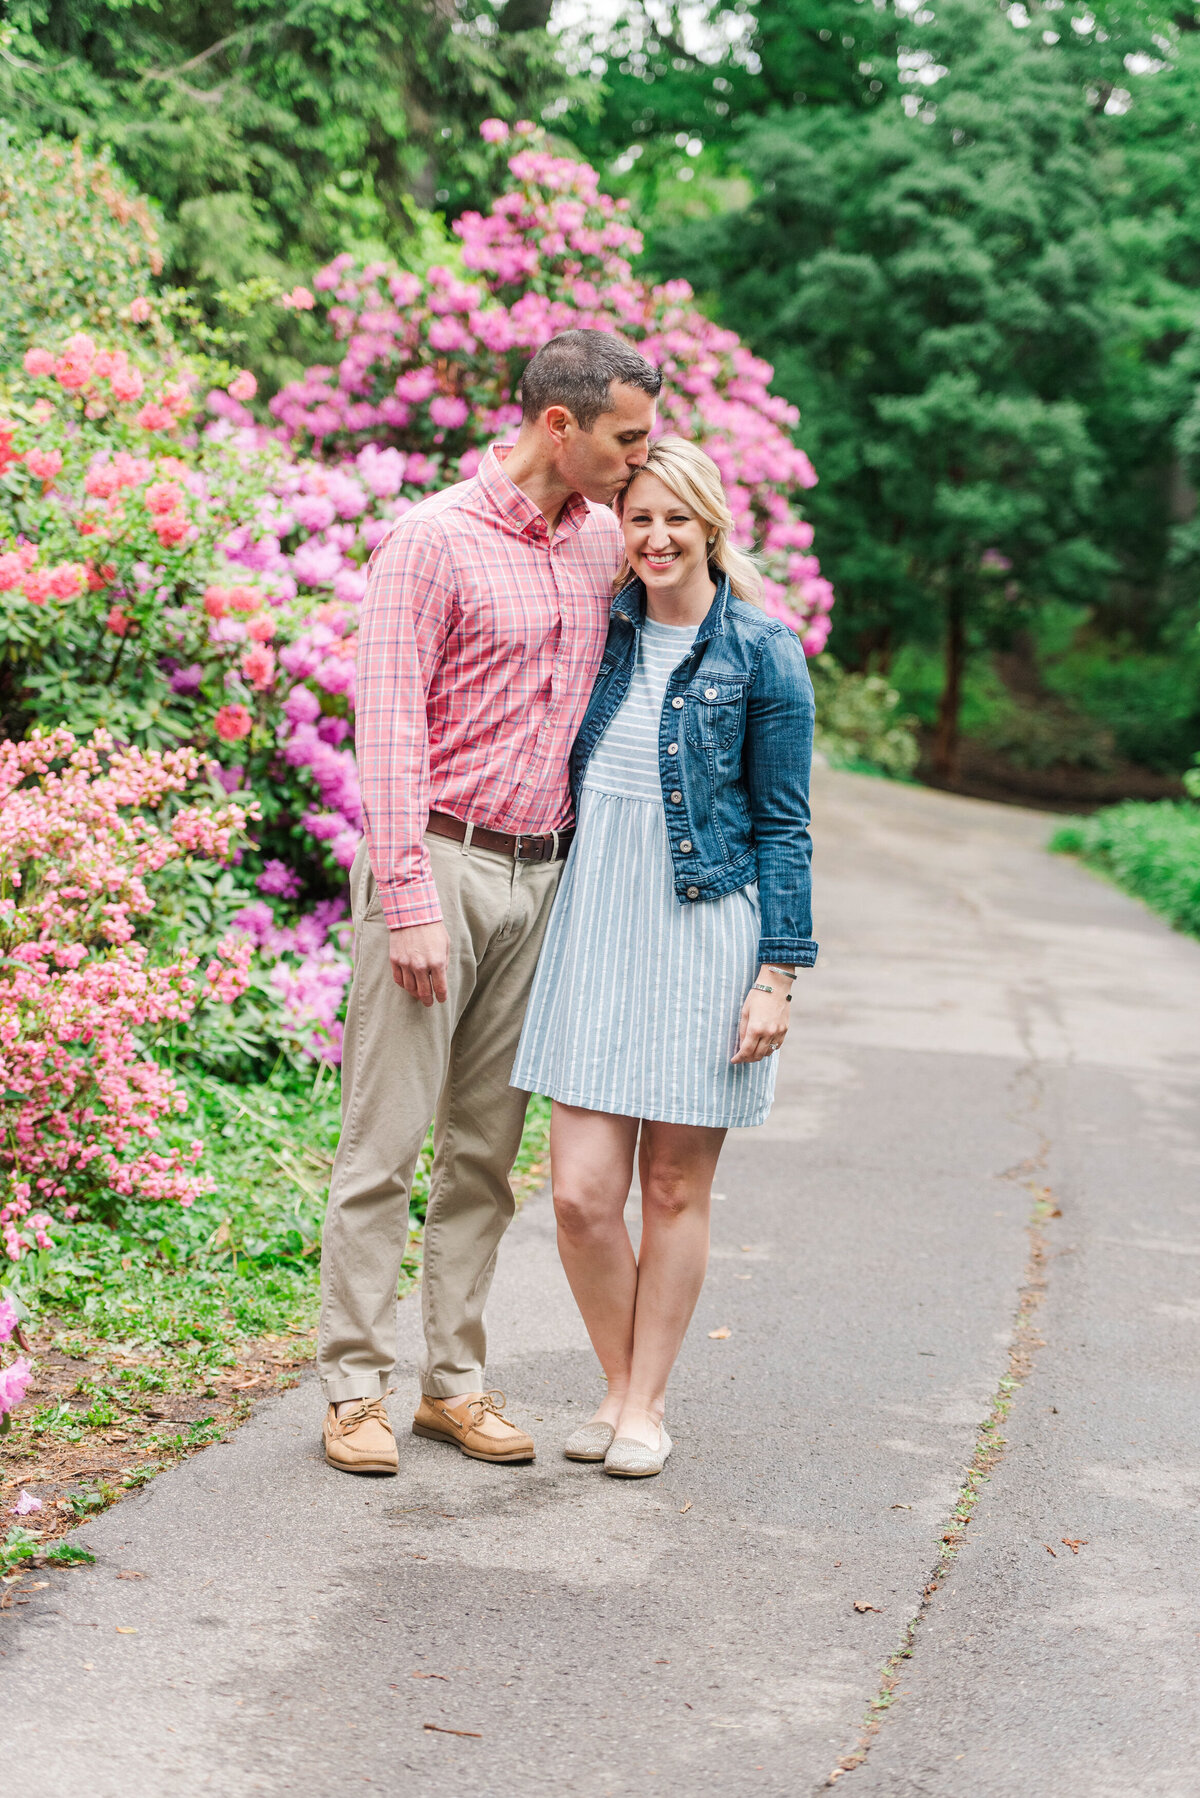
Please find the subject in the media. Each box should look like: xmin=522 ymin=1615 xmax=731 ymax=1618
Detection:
xmin=0 ymin=775 xmax=1200 ymax=1798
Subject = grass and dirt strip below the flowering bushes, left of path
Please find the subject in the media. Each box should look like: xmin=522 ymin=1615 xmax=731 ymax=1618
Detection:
xmin=0 ymin=1066 xmax=551 ymax=1560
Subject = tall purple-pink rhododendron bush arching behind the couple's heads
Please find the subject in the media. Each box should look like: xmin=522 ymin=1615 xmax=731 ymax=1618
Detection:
xmin=270 ymin=134 xmax=833 ymax=654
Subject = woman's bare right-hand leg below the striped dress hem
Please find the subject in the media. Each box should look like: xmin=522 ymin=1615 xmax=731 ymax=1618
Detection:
xmin=610 ymin=1124 xmax=725 ymax=1449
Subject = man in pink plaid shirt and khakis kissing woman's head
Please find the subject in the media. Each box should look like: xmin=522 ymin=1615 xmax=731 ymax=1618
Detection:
xmin=317 ymin=331 xmax=660 ymax=1473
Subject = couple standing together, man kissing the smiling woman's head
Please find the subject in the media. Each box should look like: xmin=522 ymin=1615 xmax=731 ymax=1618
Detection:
xmin=318 ymin=331 xmax=817 ymax=1478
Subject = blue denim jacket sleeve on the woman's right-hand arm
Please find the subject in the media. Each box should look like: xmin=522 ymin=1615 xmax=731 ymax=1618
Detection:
xmin=743 ymin=629 xmax=817 ymax=967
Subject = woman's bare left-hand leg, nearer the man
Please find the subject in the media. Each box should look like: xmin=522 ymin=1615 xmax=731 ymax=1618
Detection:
xmin=551 ymin=1100 xmax=637 ymax=1428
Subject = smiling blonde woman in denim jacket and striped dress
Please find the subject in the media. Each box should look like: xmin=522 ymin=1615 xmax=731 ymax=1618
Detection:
xmin=513 ymin=437 xmax=817 ymax=1478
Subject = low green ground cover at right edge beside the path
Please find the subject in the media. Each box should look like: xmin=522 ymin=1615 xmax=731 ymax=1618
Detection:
xmin=1049 ymin=800 xmax=1200 ymax=937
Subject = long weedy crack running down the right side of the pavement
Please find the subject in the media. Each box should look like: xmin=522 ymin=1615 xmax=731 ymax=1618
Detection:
xmin=815 ymin=1042 xmax=1061 ymax=1793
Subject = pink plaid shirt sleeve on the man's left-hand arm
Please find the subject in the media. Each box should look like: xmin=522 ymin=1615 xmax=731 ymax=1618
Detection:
xmin=354 ymin=518 xmax=457 ymax=930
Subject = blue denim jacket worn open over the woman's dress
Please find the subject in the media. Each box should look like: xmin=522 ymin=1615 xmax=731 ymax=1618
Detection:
xmin=570 ymin=575 xmax=817 ymax=967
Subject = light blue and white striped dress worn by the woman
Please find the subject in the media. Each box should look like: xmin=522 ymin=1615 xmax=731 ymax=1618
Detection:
xmin=511 ymin=619 xmax=779 ymax=1126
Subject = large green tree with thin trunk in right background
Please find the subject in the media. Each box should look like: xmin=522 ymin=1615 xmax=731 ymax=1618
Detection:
xmin=655 ymin=0 xmax=1144 ymax=779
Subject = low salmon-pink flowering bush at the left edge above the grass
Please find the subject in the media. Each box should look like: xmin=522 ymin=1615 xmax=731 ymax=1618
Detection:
xmin=0 ymin=730 xmax=252 ymax=1260
